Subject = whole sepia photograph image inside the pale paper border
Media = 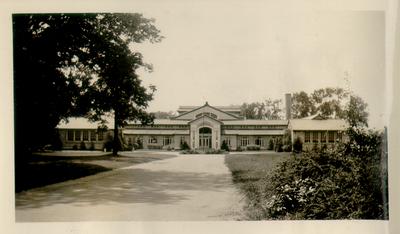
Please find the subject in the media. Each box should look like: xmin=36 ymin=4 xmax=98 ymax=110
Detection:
xmin=12 ymin=3 xmax=390 ymax=223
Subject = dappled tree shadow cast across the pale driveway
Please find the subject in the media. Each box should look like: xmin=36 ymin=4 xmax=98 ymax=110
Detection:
xmin=16 ymin=168 xmax=232 ymax=210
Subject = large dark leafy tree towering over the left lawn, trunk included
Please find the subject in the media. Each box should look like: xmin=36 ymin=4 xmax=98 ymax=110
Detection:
xmin=13 ymin=13 xmax=162 ymax=155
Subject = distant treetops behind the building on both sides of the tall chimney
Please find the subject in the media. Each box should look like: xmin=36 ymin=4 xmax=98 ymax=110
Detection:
xmin=241 ymin=87 xmax=368 ymax=127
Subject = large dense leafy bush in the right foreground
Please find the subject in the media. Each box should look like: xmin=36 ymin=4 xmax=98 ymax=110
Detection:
xmin=260 ymin=130 xmax=388 ymax=219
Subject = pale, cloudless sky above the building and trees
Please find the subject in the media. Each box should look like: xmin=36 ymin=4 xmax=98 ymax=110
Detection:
xmin=126 ymin=1 xmax=387 ymax=128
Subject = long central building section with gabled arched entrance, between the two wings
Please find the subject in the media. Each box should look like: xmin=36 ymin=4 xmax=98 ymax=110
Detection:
xmin=123 ymin=102 xmax=288 ymax=150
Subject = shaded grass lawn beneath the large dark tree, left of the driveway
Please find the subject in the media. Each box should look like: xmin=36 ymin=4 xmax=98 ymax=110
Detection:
xmin=15 ymin=152 xmax=175 ymax=192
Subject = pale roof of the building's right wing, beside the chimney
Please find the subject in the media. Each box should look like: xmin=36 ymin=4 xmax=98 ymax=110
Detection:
xmin=289 ymin=119 xmax=348 ymax=131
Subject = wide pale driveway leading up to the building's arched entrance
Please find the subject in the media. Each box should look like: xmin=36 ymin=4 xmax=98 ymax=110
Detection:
xmin=16 ymin=155 xmax=243 ymax=222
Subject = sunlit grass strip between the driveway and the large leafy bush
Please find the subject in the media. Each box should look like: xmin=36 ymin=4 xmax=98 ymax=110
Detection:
xmin=225 ymin=152 xmax=291 ymax=219
